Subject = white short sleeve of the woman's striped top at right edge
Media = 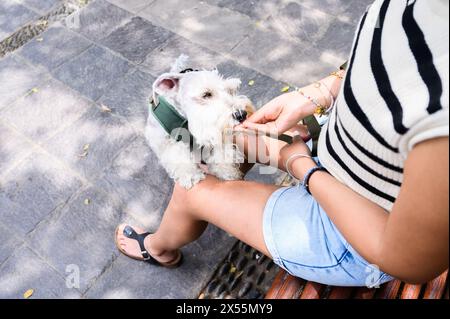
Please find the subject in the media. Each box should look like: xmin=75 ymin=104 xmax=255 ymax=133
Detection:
xmin=399 ymin=108 xmax=449 ymax=159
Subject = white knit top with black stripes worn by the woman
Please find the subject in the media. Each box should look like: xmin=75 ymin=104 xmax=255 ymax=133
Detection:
xmin=318 ymin=0 xmax=449 ymax=211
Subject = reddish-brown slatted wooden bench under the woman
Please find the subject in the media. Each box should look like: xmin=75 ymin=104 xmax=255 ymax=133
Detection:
xmin=266 ymin=270 xmax=449 ymax=299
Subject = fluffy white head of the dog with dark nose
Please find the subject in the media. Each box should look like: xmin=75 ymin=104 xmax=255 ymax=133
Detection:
xmin=153 ymin=70 xmax=254 ymax=146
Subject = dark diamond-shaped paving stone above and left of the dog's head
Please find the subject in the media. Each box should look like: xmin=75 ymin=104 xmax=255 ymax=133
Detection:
xmin=101 ymin=17 xmax=172 ymax=63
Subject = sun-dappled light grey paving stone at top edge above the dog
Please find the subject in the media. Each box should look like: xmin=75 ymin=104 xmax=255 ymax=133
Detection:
xmin=138 ymin=0 xmax=253 ymax=52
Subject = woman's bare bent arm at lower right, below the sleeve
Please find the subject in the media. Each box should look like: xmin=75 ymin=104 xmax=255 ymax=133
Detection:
xmin=290 ymin=138 xmax=449 ymax=283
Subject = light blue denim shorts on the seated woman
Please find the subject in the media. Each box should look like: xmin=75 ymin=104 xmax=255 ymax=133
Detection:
xmin=263 ymin=187 xmax=393 ymax=287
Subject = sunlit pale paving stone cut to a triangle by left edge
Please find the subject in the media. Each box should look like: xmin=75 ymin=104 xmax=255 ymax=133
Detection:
xmin=0 ymin=55 xmax=48 ymax=109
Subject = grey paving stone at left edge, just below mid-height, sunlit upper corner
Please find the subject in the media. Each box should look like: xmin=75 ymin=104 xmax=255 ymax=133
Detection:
xmin=0 ymin=152 xmax=82 ymax=236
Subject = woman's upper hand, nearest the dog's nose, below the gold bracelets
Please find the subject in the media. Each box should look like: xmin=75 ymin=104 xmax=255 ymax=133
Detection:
xmin=242 ymin=92 xmax=310 ymax=135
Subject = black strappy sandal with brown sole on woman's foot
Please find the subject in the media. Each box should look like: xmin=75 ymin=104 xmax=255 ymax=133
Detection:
xmin=115 ymin=226 xmax=183 ymax=268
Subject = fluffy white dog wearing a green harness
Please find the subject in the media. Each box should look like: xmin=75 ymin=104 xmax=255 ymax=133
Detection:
xmin=145 ymin=55 xmax=254 ymax=189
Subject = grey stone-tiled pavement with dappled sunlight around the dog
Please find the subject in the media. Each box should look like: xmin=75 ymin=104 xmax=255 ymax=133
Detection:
xmin=0 ymin=0 xmax=371 ymax=298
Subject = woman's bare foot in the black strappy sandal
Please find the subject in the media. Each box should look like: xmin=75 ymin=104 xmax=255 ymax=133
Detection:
xmin=115 ymin=224 xmax=182 ymax=267
